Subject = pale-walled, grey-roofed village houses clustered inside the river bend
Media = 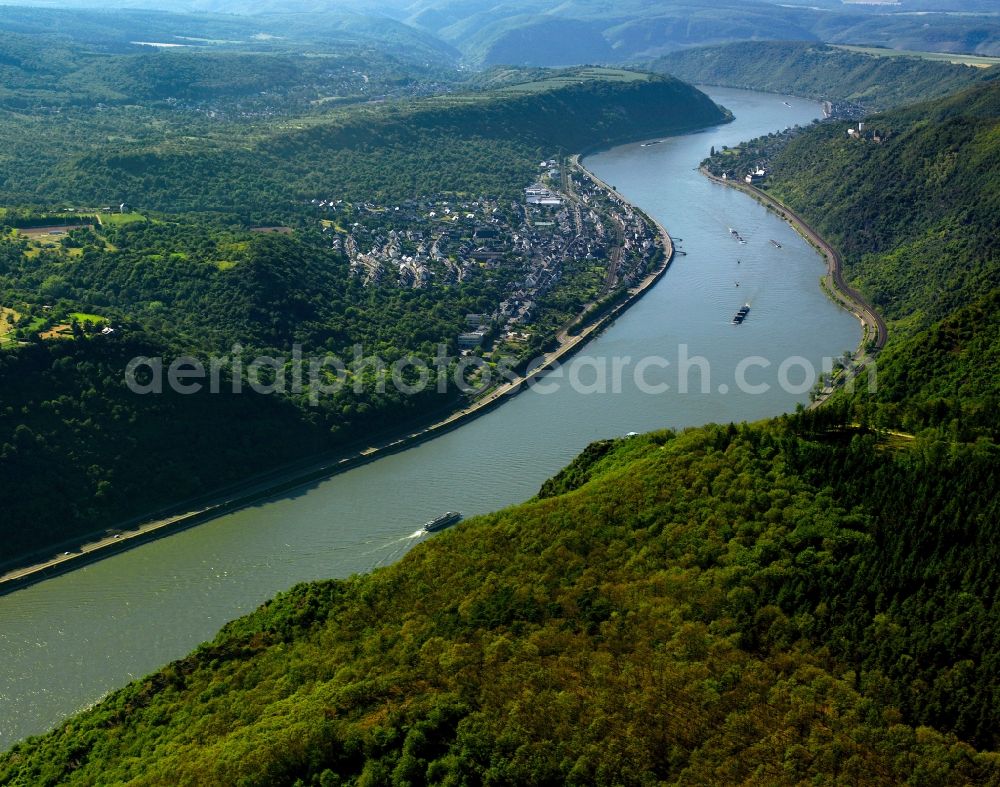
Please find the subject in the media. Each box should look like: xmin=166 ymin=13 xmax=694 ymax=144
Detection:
xmin=311 ymin=161 xmax=656 ymax=351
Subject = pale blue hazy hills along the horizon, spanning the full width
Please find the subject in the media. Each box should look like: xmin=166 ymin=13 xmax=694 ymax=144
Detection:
xmin=3 ymin=0 xmax=1000 ymax=65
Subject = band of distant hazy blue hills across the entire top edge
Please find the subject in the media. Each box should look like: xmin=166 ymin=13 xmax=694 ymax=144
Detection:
xmin=0 ymin=0 xmax=1000 ymax=66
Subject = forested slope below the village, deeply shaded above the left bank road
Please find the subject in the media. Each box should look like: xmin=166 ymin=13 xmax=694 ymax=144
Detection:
xmin=0 ymin=222 xmax=492 ymax=563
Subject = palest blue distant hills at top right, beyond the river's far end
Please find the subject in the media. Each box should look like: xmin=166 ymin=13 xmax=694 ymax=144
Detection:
xmin=395 ymin=0 xmax=1000 ymax=65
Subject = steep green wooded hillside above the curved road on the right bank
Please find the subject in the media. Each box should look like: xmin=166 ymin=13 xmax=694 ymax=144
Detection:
xmin=767 ymin=83 xmax=1000 ymax=308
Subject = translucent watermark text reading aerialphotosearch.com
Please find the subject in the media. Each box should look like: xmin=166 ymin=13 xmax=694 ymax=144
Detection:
xmin=125 ymin=344 xmax=876 ymax=405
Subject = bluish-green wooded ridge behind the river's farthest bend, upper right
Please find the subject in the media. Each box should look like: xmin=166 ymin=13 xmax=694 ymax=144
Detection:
xmin=650 ymin=41 xmax=998 ymax=110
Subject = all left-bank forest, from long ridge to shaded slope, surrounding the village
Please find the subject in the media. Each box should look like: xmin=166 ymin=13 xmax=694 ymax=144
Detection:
xmin=0 ymin=70 xmax=726 ymax=565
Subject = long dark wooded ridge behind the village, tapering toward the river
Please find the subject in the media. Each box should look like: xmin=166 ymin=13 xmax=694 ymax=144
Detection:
xmin=0 ymin=75 xmax=725 ymax=211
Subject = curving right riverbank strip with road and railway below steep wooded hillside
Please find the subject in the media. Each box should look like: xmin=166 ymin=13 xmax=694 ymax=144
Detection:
xmin=700 ymin=167 xmax=889 ymax=407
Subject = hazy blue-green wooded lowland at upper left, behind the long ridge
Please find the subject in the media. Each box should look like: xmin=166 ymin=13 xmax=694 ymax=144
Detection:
xmin=0 ymin=28 xmax=461 ymax=222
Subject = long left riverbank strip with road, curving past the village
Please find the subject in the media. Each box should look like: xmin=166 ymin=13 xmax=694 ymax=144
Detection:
xmin=0 ymin=155 xmax=674 ymax=595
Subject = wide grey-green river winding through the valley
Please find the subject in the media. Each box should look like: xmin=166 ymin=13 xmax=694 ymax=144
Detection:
xmin=0 ymin=89 xmax=861 ymax=749
